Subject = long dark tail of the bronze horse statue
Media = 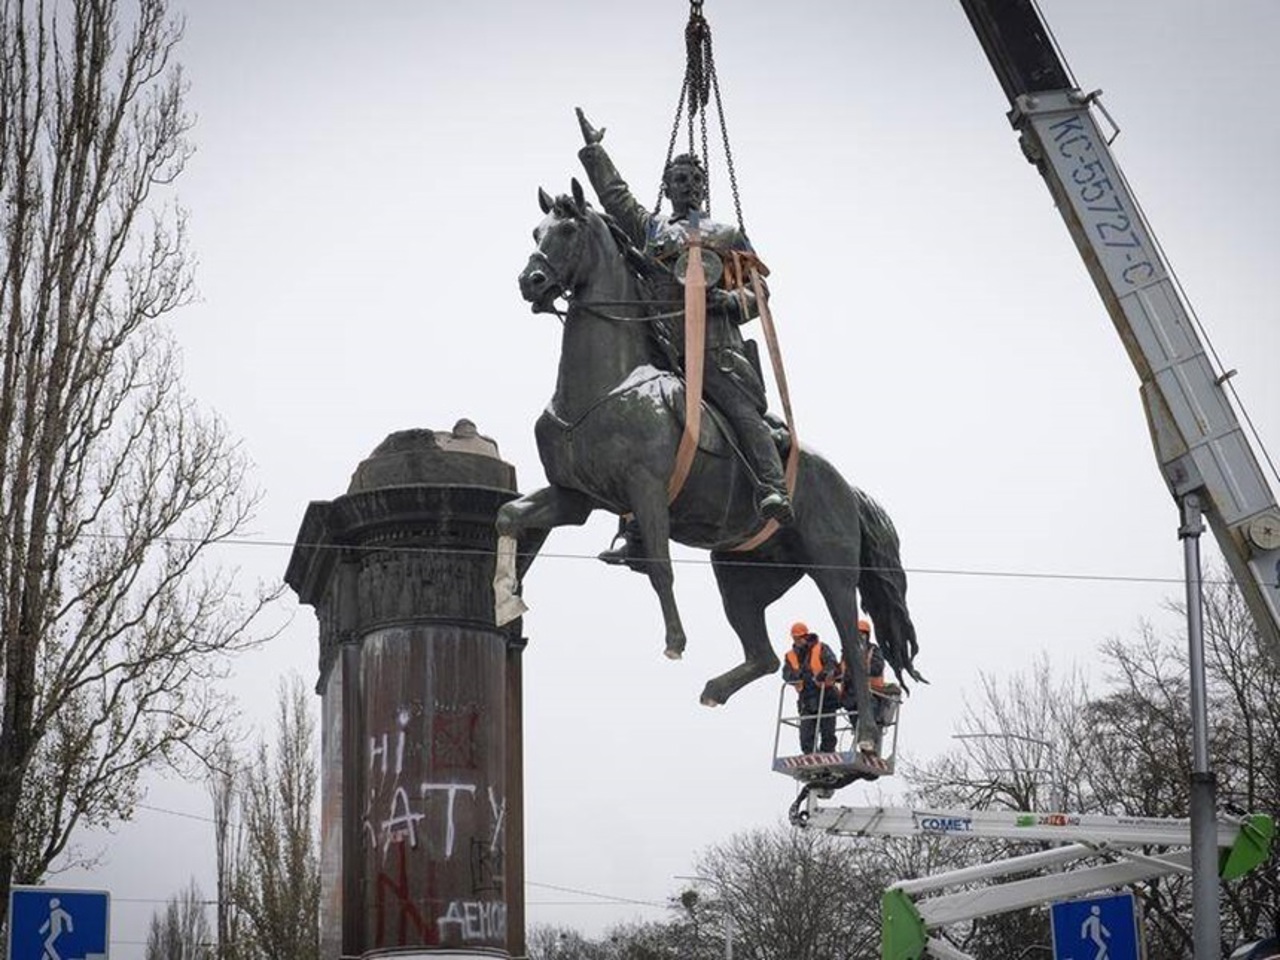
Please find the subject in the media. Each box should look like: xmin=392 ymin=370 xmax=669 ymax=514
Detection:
xmin=852 ymin=486 xmax=929 ymax=690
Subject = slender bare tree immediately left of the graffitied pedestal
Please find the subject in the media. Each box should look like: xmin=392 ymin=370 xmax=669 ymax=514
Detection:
xmin=234 ymin=676 xmax=320 ymax=960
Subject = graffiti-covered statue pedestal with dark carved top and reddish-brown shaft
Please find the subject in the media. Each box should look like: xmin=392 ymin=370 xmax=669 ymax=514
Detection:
xmin=285 ymin=420 xmax=524 ymax=960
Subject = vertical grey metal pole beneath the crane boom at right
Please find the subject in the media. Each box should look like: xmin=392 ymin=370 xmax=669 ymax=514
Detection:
xmin=1178 ymin=494 xmax=1222 ymax=960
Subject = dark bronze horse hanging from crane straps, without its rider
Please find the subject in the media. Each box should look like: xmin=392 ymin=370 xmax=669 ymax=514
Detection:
xmin=498 ymin=180 xmax=923 ymax=749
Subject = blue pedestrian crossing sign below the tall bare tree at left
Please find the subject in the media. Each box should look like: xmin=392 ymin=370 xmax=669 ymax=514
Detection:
xmin=8 ymin=887 xmax=111 ymax=960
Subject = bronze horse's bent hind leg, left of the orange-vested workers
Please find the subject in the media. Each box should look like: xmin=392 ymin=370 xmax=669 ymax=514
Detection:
xmin=701 ymin=553 xmax=800 ymax=707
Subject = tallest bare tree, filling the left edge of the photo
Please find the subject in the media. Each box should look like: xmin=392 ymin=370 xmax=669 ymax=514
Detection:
xmin=0 ymin=0 xmax=275 ymax=920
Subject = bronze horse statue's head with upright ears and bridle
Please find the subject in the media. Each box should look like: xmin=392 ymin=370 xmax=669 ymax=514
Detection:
xmin=518 ymin=179 xmax=596 ymax=314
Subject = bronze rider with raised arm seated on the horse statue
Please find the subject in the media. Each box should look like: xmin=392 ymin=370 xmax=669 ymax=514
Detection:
xmin=577 ymin=108 xmax=792 ymax=563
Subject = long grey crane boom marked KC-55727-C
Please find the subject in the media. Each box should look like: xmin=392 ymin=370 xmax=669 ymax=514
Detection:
xmin=960 ymin=0 xmax=1280 ymax=659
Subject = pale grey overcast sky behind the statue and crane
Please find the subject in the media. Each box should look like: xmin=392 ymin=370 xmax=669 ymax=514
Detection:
xmin=52 ymin=0 xmax=1280 ymax=960
